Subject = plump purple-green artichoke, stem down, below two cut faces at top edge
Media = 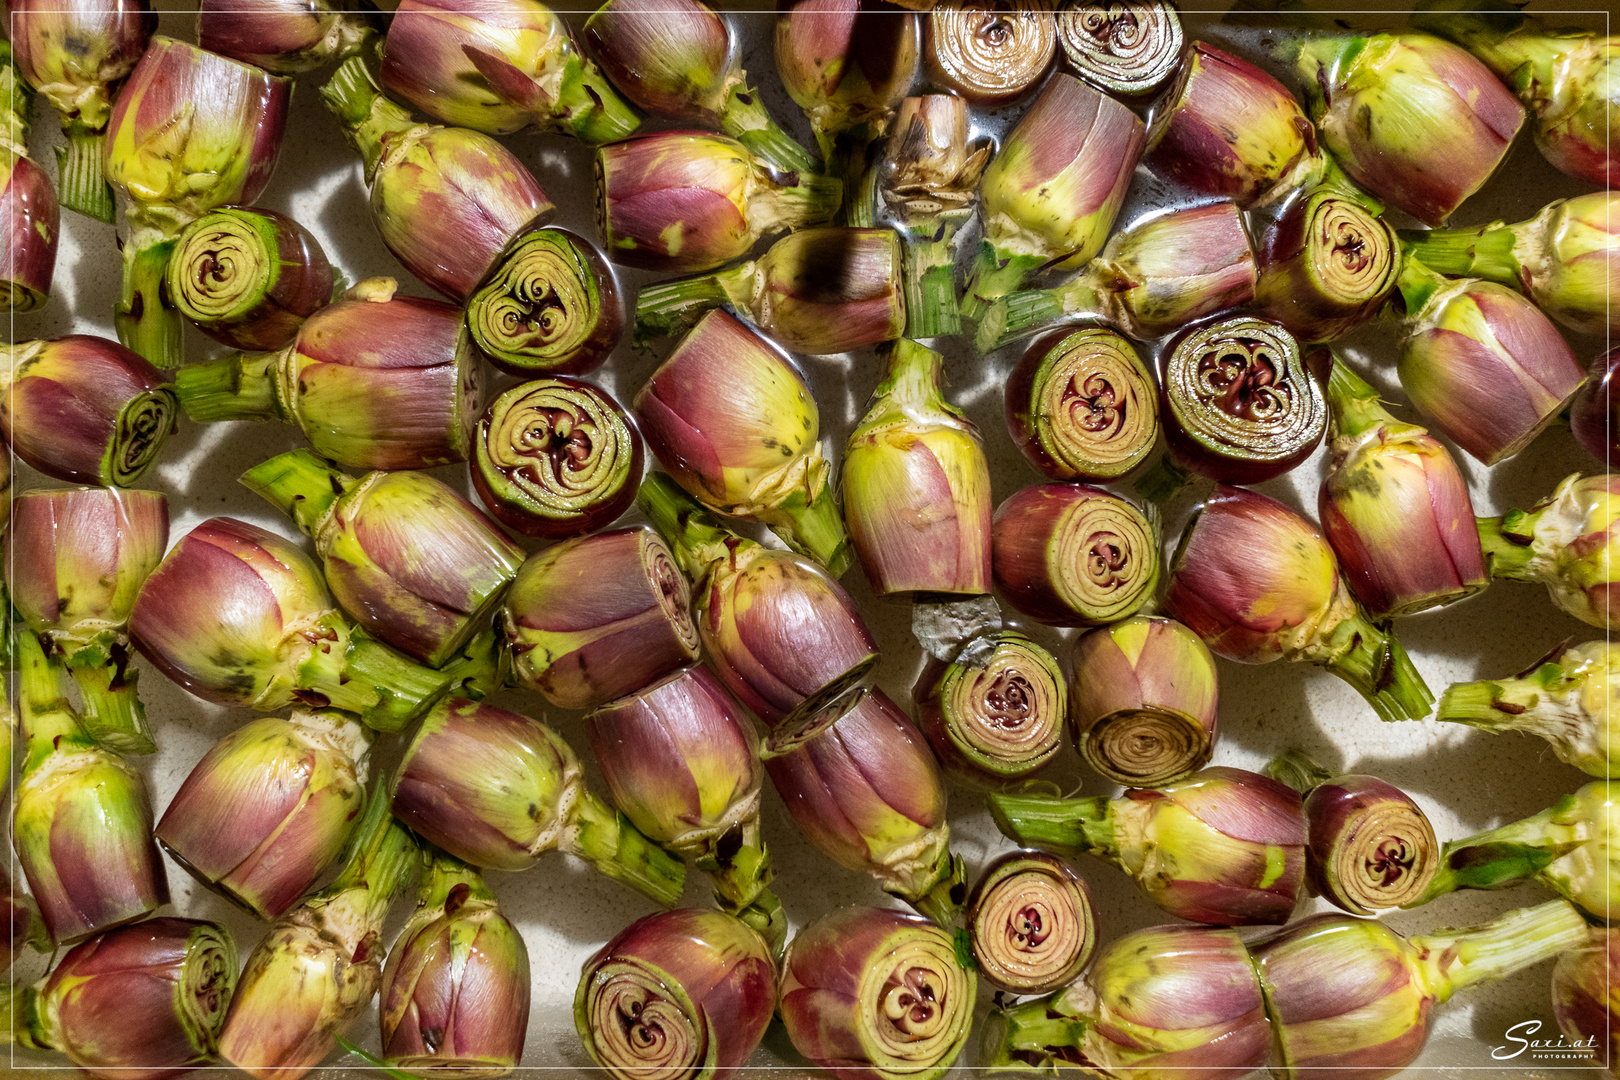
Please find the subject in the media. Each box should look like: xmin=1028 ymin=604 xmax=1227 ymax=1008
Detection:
xmin=962 ymin=71 xmax=1144 ymax=319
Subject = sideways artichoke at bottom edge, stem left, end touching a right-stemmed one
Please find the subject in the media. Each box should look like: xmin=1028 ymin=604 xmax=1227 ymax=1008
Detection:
xmin=983 ymin=926 xmax=1272 ymax=1080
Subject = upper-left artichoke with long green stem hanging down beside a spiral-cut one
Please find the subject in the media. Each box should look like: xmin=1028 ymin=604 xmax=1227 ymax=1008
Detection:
xmin=102 ymin=37 xmax=293 ymax=368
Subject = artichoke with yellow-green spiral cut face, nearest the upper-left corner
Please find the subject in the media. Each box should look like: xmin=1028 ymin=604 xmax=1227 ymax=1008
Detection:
xmin=165 ymin=207 xmax=334 ymax=350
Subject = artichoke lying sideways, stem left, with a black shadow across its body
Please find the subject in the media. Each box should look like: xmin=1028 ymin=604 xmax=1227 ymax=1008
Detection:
xmin=635 ymin=225 xmax=906 ymax=355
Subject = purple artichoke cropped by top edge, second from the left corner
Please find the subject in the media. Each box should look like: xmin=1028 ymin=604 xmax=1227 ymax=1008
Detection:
xmin=198 ymin=0 xmax=381 ymax=74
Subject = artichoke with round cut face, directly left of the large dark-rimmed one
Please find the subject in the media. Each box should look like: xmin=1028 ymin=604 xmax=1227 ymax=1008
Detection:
xmin=1004 ymin=327 xmax=1158 ymax=483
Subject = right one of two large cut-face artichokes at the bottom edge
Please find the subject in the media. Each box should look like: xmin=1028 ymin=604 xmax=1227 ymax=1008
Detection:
xmin=781 ymin=907 xmax=977 ymax=1080
